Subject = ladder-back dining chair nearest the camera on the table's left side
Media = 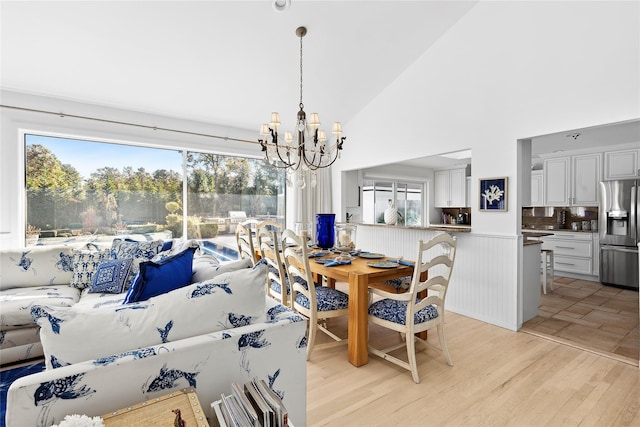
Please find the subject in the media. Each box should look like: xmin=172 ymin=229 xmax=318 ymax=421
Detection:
xmin=282 ymin=229 xmax=349 ymax=360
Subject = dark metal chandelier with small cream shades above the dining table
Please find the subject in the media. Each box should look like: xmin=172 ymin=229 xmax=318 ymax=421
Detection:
xmin=258 ymin=27 xmax=346 ymax=188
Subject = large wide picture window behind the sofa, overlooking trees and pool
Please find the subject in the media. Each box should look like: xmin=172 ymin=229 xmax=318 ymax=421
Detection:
xmin=25 ymin=134 xmax=285 ymax=252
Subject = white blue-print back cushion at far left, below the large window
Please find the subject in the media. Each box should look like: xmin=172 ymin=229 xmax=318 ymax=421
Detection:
xmin=0 ymin=243 xmax=84 ymax=290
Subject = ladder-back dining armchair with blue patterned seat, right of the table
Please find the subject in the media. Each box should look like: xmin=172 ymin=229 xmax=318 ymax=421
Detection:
xmin=369 ymin=233 xmax=456 ymax=384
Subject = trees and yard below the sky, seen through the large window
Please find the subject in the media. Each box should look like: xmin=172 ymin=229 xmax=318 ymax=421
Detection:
xmin=26 ymin=138 xmax=284 ymax=238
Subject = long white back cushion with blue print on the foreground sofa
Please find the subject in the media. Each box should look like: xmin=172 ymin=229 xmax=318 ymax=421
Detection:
xmin=31 ymin=263 xmax=267 ymax=368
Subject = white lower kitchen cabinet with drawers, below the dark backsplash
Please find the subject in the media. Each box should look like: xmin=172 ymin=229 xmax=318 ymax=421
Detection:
xmin=542 ymin=231 xmax=594 ymax=275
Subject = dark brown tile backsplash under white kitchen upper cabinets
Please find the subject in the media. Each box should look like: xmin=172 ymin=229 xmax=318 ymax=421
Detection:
xmin=522 ymin=206 xmax=598 ymax=231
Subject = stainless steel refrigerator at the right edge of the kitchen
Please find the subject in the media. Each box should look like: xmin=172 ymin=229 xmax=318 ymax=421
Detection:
xmin=598 ymin=179 xmax=640 ymax=289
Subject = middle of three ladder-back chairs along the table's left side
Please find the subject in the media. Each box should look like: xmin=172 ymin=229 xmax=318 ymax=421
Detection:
xmin=256 ymin=221 xmax=291 ymax=307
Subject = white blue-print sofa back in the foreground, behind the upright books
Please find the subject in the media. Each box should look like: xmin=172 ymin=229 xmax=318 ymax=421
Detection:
xmin=6 ymin=302 xmax=306 ymax=426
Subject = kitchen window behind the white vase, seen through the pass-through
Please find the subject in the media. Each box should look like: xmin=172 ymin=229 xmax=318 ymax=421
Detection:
xmin=362 ymin=179 xmax=424 ymax=227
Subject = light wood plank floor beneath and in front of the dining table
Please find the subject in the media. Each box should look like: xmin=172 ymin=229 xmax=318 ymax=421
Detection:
xmin=307 ymin=286 xmax=640 ymax=427
